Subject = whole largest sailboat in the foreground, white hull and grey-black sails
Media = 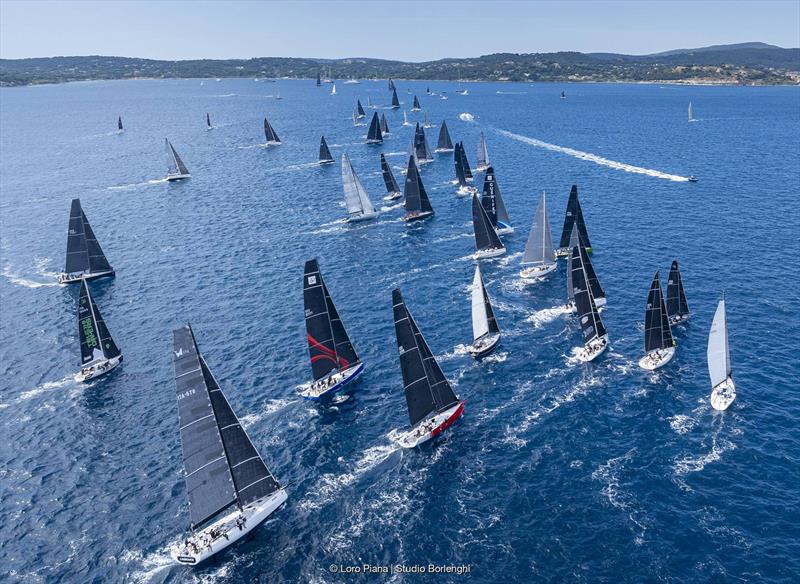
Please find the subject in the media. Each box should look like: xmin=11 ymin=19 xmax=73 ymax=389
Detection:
xmin=170 ymin=325 xmax=287 ymax=566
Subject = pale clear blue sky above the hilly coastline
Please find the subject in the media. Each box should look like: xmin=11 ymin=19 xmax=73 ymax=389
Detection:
xmin=0 ymin=0 xmax=800 ymax=61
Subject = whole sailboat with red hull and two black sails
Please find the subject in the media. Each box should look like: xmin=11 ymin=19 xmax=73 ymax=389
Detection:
xmin=392 ymin=288 xmax=464 ymax=448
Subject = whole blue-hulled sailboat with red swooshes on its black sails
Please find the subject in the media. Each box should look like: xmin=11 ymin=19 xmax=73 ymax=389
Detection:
xmin=300 ymin=259 xmax=364 ymax=400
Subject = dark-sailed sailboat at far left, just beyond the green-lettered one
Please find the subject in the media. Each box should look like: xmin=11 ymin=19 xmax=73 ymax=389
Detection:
xmin=58 ymin=199 xmax=114 ymax=284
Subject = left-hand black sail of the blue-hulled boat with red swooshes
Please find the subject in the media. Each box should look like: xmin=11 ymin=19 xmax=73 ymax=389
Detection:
xmin=303 ymin=260 xmax=339 ymax=381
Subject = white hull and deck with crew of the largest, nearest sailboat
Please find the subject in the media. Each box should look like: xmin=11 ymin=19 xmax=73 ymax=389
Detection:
xmin=170 ymin=489 xmax=287 ymax=566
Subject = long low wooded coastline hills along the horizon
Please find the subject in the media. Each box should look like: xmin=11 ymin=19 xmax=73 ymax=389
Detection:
xmin=0 ymin=43 xmax=800 ymax=86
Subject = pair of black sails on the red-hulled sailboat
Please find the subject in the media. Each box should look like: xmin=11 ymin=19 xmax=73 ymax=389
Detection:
xmin=392 ymin=288 xmax=458 ymax=426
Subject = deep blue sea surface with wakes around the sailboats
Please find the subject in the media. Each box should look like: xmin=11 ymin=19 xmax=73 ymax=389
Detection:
xmin=0 ymin=79 xmax=800 ymax=583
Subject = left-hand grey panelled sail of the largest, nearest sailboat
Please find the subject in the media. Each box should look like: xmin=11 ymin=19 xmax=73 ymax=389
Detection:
xmin=172 ymin=325 xmax=237 ymax=529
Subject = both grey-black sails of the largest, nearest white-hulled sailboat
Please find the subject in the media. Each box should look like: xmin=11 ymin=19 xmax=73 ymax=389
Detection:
xmin=172 ymin=325 xmax=281 ymax=529
